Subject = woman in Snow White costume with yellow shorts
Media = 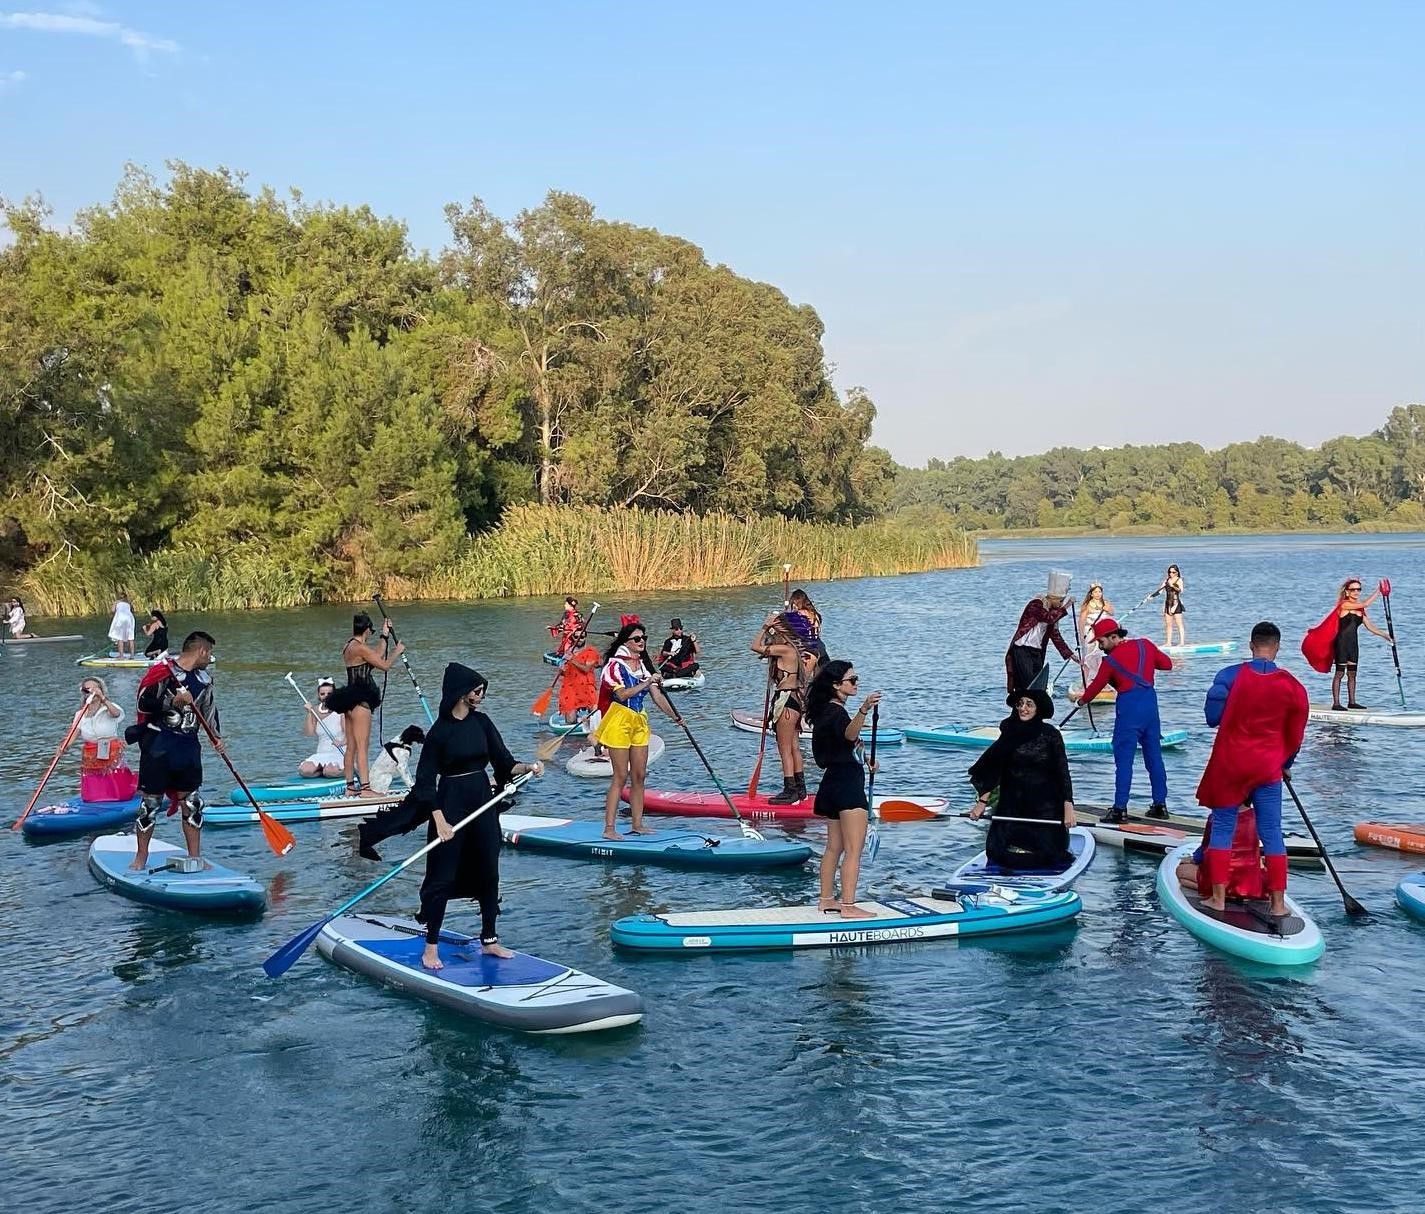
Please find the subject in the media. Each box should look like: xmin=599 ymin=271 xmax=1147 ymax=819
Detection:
xmin=594 ymin=616 xmax=683 ymax=839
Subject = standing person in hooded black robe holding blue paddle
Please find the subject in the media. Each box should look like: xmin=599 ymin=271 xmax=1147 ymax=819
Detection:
xmin=359 ymin=661 xmax=544 ymax=969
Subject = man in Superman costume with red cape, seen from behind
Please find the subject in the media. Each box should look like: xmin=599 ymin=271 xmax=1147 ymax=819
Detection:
xmin=1197 ymin=620 xmax=1310 ymax=918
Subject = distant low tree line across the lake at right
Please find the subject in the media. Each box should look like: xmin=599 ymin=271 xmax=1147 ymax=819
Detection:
xmin=892 ymin=405 xmax=1425 ymax=530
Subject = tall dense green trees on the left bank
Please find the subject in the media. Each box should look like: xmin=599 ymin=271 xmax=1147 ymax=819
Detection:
xmin=0 ymin=164 xmax=893 ymax=587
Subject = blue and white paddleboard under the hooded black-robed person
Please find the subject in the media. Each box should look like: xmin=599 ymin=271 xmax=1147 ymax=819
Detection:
xmin=316 ymin=915 xmax=643 ymax=1033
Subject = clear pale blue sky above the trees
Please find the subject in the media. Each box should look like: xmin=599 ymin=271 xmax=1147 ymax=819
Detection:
xmin=0 ymin=0 xmax=1425 ymax=463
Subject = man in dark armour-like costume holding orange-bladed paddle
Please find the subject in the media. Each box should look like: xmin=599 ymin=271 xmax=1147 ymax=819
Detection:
xmin=130 ymin=631 xmax=222 ymax=871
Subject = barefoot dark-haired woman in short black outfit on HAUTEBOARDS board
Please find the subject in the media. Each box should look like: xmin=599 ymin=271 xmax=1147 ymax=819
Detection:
xmin=807 ymin=661 xmax=881 ymax=919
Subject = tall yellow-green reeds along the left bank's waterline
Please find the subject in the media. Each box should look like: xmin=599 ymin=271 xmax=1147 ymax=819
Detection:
xmin=19 ymin=506 xmax=979 ymax=616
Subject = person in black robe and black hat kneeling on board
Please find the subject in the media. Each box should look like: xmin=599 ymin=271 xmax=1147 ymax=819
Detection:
xmin=969 ymin=688 xmax=1076 ymax=872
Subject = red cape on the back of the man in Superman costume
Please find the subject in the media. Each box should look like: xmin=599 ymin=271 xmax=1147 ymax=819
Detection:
xmin=1197 ymin=663 xmax=1308 ymax=809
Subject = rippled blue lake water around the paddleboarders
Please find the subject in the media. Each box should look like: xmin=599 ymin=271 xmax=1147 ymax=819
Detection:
xmin=0 ymin=536 xmax=1425 ymax=1214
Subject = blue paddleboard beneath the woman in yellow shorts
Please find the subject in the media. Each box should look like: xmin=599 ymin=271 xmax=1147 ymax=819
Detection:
xmin=500 ymin=814 xmax=811 ymax=872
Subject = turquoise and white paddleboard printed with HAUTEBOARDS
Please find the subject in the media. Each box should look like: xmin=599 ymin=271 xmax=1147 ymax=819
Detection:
xmin=611 ymin=889 xmax=1083 ymax=953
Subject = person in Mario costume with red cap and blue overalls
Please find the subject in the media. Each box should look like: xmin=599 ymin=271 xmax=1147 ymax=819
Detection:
xmin=1080 ymin=616 xmax=1173 ymax=826
